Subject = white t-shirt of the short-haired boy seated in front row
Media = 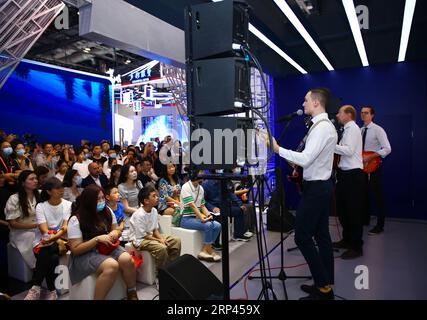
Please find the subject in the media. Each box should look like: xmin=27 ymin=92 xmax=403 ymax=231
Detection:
xmin=129 ymin=207 xmax=159 ymax=247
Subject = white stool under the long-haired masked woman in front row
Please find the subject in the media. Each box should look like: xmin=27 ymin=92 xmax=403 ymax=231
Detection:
xmin=70 ymin=271 xmax=127 ymax=300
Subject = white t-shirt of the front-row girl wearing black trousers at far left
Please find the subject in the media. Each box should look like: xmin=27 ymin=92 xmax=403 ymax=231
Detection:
xmin=33 ymin=199 xmax=71 ymax=246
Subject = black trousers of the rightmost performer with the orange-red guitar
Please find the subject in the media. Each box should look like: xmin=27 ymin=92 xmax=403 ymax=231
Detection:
xmin=364 ymin=167 xmax=385 ymax=228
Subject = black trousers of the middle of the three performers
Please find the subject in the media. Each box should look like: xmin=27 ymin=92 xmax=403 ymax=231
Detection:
xmin=336 ymin=169 xmax=365 ymax=251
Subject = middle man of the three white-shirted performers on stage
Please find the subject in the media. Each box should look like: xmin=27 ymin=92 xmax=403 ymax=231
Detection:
xmin=333 ymin=105 xmax=365 ymax=260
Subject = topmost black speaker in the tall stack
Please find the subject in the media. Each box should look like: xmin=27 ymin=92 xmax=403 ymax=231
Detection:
xmin=185 ymin=0 xmax=249 ymax=60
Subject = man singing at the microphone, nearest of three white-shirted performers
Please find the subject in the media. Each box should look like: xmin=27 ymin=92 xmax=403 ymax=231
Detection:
xmin=273 ymin=88 xmax=338 ymax=300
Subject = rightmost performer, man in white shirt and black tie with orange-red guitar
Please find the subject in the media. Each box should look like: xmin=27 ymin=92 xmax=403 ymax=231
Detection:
xmin=361 ymin=106 xmax=391 ymax=235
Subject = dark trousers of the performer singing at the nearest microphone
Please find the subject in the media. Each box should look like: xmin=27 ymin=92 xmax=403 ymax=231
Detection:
xmin=295 ymin=180 xmax=334 ymax=287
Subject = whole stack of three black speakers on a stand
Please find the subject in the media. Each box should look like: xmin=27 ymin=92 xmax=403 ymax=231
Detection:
xmin=185 ymin=0 xmax=252 ymax=170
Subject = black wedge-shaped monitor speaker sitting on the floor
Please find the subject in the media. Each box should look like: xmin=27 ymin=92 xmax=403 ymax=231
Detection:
xmin=159 ymin=254 xmax=223 ymax=300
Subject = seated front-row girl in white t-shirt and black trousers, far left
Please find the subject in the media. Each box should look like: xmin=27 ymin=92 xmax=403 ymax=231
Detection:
xmin=25 ymin=177 xmax=71 ymax=300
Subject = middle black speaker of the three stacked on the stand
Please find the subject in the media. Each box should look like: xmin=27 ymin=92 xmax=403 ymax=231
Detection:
xmin=187 ymin=57 xmax=251 ymax=116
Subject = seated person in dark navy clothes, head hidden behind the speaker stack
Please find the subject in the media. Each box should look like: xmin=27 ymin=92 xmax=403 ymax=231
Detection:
xmin=203 ymin=180 xmax=250 ymax=244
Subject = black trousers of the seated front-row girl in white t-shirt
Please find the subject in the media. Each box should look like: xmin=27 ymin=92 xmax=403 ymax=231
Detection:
xmin=33 ymin=243 xmax=59 ymax=291
